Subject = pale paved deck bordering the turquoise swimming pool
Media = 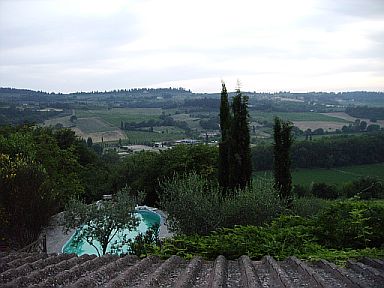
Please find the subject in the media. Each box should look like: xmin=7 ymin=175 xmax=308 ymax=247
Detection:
xmin=43 ymin=206 xmax=173 ymax=253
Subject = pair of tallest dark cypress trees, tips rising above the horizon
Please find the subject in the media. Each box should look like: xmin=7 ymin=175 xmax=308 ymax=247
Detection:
xmin=219 ymin=84 xmax=252 ymax=192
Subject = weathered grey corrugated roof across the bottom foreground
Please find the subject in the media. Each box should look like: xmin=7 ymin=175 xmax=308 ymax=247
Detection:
xmin=0 ymin=253 xmax=384 ymax=288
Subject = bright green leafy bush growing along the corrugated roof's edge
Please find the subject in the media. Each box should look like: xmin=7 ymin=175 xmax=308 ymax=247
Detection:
xmin=148 ymin=216 xmax=384 ymax=263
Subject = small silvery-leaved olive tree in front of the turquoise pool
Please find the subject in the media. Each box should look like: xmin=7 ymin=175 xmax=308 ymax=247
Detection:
xmin=63 ymin=188 xmax=141 ymax=256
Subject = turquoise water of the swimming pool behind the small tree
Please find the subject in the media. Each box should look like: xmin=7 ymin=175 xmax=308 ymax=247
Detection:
xmin=62 ymin=210 xmax=160 ymax=256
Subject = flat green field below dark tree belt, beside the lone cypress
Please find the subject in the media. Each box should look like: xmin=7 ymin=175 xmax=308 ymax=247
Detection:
xmin=254 ymin=163 xmax=384 ymax=186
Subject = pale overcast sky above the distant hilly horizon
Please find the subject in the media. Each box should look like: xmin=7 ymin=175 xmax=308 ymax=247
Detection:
xmin=0 ymin=0 xmax=384 ymax=92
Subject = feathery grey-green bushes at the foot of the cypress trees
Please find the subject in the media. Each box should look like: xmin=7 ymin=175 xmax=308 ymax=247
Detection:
xmin=160 ymin=173 xmax=281 ymax=235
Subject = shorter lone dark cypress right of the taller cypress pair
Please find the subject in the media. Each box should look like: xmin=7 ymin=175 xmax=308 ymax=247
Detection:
xmin=273 ymin=117 xmax=293 ymax=208
